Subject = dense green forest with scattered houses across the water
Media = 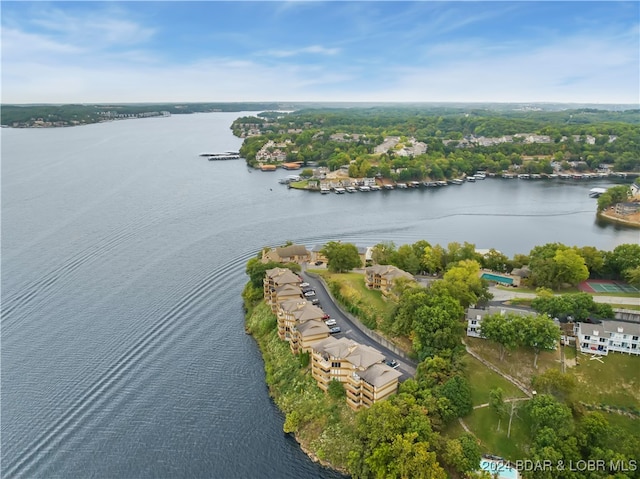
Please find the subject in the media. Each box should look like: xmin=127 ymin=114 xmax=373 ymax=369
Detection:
xmin=231 ymin=107 xmax=640 ymax=177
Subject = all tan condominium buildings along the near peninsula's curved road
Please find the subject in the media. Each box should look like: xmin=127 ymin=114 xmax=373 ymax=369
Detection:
xmin=262 ymin=245 xmax=410 ymax=410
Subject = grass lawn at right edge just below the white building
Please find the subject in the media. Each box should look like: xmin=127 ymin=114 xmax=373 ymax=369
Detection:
xmin=567 ymin=353 xmax=640 ymax=409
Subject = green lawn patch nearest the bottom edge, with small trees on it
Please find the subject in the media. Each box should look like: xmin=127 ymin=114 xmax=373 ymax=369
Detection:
xmin=463 ymin=401 xmax=531 ymax=461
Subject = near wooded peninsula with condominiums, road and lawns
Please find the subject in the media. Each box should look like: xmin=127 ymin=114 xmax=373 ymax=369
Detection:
xmin=243 ymin=241 xmax=640 ymax=478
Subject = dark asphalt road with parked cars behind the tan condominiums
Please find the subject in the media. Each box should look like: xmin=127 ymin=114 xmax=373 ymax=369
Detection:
xmin=301 ymin=271 xmax=416 ymax=381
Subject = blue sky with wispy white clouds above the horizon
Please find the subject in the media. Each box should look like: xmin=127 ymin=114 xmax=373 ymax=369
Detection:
xmin=2 ymin=0 xmax=640 ymax=104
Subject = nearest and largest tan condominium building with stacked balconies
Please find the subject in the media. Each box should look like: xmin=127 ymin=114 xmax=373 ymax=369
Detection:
xmin=311 ymin=337 xmax=402 ymax=410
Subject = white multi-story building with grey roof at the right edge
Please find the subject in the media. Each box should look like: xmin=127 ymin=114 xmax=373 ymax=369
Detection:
xmin=574 ymin=321 xmax=640 ymax=356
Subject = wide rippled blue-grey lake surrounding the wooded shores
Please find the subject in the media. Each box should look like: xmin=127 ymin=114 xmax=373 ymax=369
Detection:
xmin=1 ymin=112 xmax=638 ymax=478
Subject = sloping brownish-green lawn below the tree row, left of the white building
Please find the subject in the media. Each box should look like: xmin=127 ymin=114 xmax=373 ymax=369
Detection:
xmin=465 ymin=337 xmax=560 ymax=384
